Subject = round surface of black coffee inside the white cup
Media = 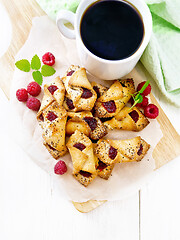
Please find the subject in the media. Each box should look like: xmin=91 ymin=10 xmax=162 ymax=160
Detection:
xmin=80 ymin=0 xmax=144 ymax=60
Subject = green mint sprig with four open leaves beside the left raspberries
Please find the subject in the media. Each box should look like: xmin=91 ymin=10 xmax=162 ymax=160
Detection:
xmin=15 ymin=54 xmax=56 ymax=85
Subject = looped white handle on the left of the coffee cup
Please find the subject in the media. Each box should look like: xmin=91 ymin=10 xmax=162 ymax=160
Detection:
xmin=56 ymin=10 xmax=76 ymax=39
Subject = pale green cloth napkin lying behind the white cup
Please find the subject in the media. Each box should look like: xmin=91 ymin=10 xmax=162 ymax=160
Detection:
xmin=36 ymin=0 xmax=180 ymax=107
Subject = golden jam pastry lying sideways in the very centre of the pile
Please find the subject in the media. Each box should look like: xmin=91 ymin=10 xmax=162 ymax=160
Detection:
xmin=66 ymin=111 xmax=107 ymax=140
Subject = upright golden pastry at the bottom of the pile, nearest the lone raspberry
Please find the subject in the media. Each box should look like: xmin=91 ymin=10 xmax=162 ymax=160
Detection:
xmin=67 ymin=130 xmax=97 ymax=187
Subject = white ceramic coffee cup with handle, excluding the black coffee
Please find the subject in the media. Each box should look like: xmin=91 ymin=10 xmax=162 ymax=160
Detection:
xmin=56 ymin=0 xmax=152 ymax=80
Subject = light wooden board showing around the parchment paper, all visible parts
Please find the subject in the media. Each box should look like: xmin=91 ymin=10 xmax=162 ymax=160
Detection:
xmin=0 ymin=0 xmax=180 ymax=212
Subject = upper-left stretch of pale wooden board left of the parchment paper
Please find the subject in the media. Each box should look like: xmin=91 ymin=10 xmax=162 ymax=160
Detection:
xmin=0 ymin=0 xmax=45 ymax=99
